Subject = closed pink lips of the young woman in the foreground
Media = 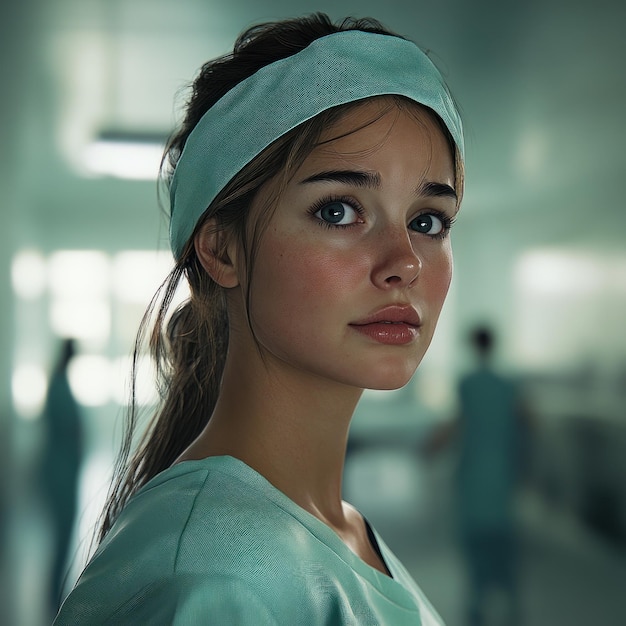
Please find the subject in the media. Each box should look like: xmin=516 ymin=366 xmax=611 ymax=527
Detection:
xmin=350 ymin=305 xmax=422 ymax=346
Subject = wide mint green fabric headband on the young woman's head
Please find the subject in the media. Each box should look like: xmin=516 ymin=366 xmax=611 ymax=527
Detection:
xmin=170 ymin=30 xmax=464 ymax=259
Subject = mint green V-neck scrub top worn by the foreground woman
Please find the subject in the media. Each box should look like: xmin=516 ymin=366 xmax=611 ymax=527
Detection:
xmin=55 ymin=456 xmax=443 ymax=626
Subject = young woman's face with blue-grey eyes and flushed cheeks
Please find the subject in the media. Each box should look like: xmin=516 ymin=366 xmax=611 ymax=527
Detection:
xmin=231 ymin=99 xmax=457 ymax=389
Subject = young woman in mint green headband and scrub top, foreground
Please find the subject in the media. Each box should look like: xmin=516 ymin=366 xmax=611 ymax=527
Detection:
xmin=56 ymin=14 xmax=463 ymax=626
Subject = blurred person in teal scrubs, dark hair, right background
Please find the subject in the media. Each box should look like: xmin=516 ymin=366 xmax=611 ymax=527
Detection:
xmin=426 ymin=326 xmax=528 ymax=626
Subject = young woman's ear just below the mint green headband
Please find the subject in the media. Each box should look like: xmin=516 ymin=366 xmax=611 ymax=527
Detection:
xmin=194 ymin=219 xmax=239 ymax=289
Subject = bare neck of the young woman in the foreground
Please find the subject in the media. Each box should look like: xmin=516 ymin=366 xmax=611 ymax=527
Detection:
xmin=179 ymin=346 xmax=362 ymax=527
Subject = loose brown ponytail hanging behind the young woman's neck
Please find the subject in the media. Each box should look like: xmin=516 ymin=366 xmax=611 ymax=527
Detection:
xmin=98 ymin=258 xmax=228 ymax=541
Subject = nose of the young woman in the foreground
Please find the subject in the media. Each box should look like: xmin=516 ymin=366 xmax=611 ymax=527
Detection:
xmin=372 ymin=227 xmax=422 ymax=289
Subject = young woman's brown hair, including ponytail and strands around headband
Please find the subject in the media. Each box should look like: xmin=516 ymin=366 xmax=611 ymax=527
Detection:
xmin=99 ymin=13 xmax=462 ymax=540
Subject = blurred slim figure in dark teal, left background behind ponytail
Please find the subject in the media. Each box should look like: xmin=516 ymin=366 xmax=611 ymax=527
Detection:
xmin=39 ymin=339 xmax=83 ymax=612
